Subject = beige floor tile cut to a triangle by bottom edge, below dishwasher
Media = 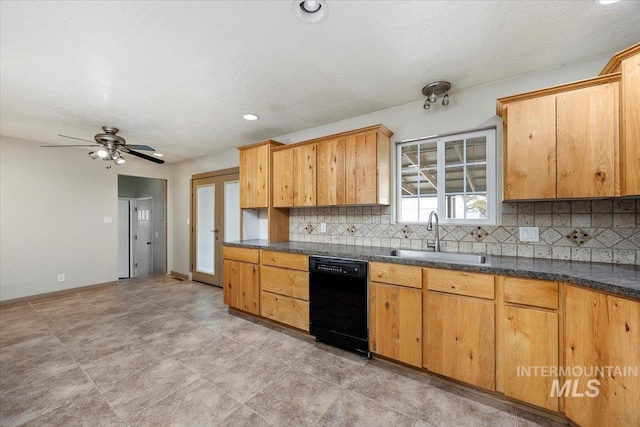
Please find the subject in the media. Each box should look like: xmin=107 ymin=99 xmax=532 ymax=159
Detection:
xmin=318 ymin=391 xmax=416 ymax=427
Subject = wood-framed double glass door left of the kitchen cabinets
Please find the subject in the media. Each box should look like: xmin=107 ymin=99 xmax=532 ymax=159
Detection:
xmin=191 ymin=168 xmax=240 ymax=286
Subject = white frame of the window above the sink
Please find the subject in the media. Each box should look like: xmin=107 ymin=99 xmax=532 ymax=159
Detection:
xmin=395 ymin=128 xmax=498 ymax=226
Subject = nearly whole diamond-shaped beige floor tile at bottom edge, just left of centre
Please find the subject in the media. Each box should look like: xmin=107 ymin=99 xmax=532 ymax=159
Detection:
xmin=246 ymin=371 xmax=343 ymax=426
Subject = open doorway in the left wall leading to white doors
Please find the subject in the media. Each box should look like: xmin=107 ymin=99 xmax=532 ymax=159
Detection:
xmin=118 ymin=175 xmax=167 ymax=279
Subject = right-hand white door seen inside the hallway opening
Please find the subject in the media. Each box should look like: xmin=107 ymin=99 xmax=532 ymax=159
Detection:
xmin=133 ymin=199 xmax=153 ymax=277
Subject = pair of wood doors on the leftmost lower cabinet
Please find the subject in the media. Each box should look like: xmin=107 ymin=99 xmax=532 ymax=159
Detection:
xmin=223 ymin=259 xmax=260 ymax=314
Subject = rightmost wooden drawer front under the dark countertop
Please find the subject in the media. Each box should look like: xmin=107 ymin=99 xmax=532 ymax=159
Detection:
xmin=504 ymin=277 xmax=558 ymax=310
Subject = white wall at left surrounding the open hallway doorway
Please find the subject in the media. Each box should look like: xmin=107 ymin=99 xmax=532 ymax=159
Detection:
xmin=0 ymin=137 xmax=172 ymax=300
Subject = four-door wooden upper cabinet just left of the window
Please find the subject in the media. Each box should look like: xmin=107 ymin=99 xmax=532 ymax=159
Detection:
xmin=273 ymin=125 xmax=392 ymax=208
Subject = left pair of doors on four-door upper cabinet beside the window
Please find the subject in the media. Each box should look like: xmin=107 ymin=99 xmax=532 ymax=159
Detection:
xmin=273 ymin=144 xmax=317 ymax=207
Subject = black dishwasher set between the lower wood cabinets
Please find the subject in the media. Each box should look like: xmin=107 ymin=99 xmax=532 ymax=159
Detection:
xmin=309 ymin=256 xmax=371 ymax=357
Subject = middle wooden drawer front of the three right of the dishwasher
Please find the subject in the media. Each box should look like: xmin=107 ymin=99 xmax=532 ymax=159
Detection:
xmin=424 ymin=268 xmax=494 ymax=299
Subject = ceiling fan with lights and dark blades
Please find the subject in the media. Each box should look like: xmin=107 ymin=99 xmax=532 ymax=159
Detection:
xmin=41 ymin=126 xmax=164 ymax=165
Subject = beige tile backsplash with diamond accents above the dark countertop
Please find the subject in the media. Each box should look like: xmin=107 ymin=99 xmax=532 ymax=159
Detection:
xmin=289 ymin=198 xmax=640 ymax=265
